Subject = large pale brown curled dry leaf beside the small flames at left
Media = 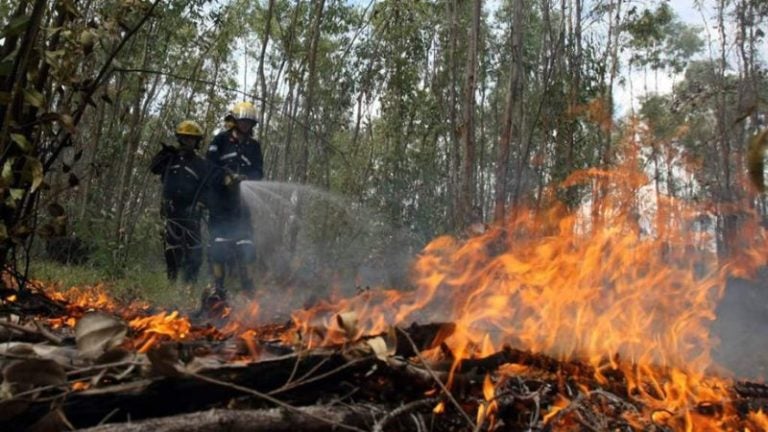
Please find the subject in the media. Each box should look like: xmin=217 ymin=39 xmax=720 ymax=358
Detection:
xmin=75 ymin=312 xmax=128 ymax=359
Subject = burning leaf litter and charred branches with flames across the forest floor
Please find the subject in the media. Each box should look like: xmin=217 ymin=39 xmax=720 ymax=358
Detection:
xmin=0 ymin=154 xmax=768 ymax=431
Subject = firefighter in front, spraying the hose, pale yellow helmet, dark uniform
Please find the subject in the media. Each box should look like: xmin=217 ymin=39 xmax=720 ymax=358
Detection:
xmin=203 ymin=102 xmax=263 ymax=307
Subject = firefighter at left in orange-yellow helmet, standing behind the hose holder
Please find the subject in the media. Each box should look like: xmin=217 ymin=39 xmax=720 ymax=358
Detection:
xmin=150 ymin=120 xmax=209 ymax=284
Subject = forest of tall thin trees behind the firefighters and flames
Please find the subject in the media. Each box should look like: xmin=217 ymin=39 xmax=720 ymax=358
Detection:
xmin=0 ymin=0 xmax=767 ymax=284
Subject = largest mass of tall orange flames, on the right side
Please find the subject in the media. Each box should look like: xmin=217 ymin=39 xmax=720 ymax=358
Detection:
xmin=284 ymin=143 xmax=768 ymax=431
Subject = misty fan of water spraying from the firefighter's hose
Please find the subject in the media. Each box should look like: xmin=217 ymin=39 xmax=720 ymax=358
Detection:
xmin=240 ymin=181 xmax=418 ymax=318
